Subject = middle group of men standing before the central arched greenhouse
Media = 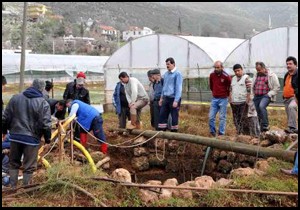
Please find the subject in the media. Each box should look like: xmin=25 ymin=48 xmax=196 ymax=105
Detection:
xmin=112 ymin=57 xmax=183 ymax=132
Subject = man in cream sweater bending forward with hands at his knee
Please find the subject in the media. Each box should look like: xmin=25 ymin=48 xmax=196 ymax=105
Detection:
xmin=119 ymin=72 xmax=149 ymax=129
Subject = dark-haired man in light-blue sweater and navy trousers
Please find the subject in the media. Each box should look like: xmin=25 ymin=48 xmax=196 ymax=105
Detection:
xmin=158 ymin=57 xmax=183 ymax=132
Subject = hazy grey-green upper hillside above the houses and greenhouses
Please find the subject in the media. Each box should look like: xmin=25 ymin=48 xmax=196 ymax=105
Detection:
xmin=42 ymin=2 xmax=298 ymax=38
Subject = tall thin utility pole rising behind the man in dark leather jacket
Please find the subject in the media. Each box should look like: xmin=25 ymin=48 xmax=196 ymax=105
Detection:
xmin=19 ymin=2 xmax=28 ymax=93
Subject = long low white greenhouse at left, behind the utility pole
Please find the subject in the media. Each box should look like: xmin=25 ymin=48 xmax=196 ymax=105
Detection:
xmin=2 ymin=53 xmax=109 ymax=83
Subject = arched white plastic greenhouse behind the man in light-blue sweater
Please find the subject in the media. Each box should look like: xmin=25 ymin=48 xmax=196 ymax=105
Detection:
xmin=104 ymin=34 xmax=245 ymax=103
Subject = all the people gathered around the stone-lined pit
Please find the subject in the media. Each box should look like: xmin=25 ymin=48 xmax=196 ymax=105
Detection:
xmin=2 ymin=56 xmax=298 ymax=188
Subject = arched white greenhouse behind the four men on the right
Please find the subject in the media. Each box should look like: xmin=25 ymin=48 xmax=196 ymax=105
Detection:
xmin=224 ymin=27 xmax=298 ymax=78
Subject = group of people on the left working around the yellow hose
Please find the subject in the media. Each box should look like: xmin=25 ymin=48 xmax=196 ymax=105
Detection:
xmin=2 ymin=72 xmax=107 ymax=189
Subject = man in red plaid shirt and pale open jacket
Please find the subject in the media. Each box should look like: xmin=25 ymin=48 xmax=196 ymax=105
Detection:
xmin=253 ymin=62 xmax=280 ymax=132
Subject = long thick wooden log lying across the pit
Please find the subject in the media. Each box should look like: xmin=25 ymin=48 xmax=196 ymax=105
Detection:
xmin=110 ymin=128 xmax=295 ymax=162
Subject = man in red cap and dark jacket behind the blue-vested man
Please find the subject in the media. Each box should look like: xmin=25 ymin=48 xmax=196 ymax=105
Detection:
xmin=63 ymin=72 xmax=91 ymax=141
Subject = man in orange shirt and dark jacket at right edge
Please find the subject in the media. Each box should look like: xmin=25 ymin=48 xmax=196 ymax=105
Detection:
xmin=283 ymin=56 xmax=298 ymax=133
